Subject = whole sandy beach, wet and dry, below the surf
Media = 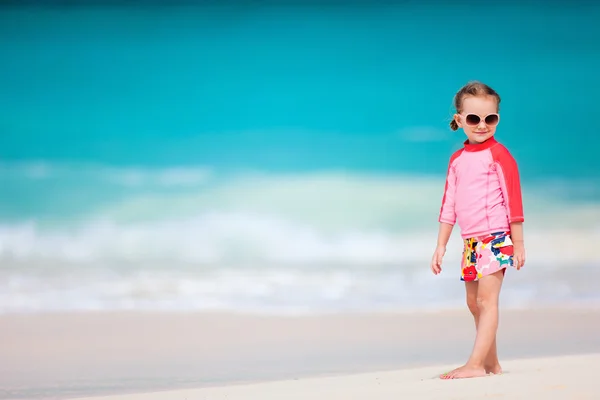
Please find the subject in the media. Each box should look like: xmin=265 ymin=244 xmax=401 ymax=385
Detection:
xmin=0 ymin=309 xmax=600 ymax=400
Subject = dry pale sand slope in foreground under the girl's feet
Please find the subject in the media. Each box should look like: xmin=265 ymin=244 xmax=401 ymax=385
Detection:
xmin=71 ymin=354 xmax=600 ymax=400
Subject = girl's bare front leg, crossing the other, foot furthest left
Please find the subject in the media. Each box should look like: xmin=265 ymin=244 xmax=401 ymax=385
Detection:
xmin=442 ymin=270 xmax=504 ymax=379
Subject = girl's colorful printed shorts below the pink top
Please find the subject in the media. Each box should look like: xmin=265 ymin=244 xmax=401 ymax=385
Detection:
xmin=460 ymin=232 xmax=513 ymax=282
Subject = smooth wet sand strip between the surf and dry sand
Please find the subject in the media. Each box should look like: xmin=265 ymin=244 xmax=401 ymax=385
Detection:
xmin=0 ymin=307 xmax=600 ymax=399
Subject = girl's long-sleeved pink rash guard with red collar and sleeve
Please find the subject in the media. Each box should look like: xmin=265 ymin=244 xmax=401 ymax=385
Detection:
xmin=439 ymin=136 xmax=525 ymax=238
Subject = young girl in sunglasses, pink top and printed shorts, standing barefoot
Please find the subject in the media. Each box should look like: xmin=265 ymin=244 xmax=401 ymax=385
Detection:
xmin=431 ymin=81 xmax=525 ymax=379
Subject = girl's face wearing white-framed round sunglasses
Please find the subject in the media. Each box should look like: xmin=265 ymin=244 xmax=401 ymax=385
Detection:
xmin=454 ymin=96 xmax=499 ymax=144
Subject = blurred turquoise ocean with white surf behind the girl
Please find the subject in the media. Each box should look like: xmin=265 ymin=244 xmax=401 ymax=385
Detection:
xmin=0 ymin=1 xmax=600 ymax=314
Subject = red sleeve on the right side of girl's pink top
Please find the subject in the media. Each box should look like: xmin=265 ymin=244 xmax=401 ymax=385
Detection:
xmin=492 ymin=146 xmax=525 ymax=223
